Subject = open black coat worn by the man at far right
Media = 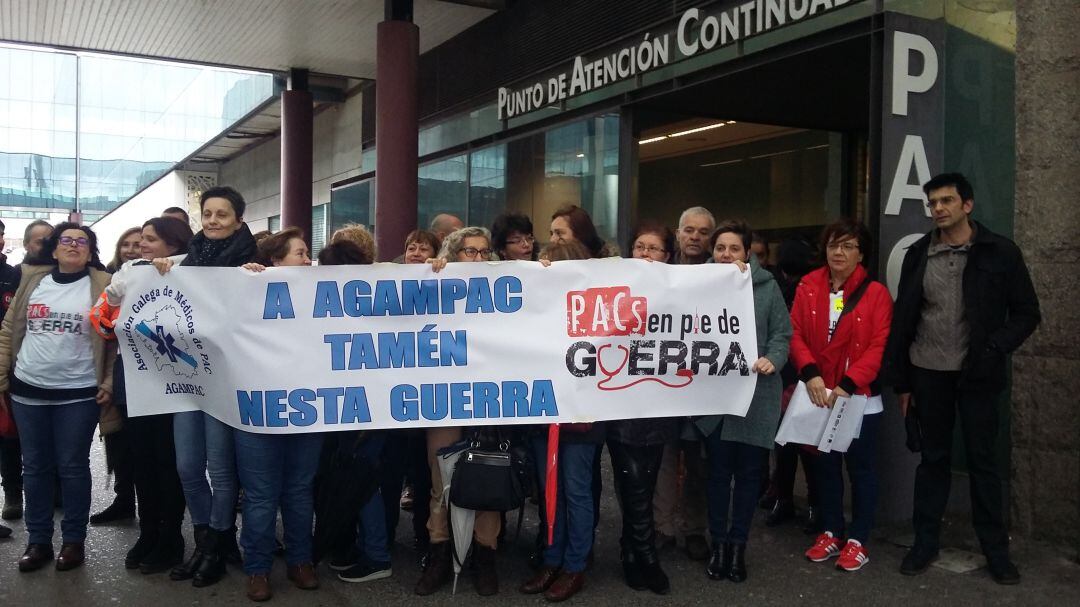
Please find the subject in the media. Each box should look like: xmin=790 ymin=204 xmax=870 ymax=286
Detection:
xmin=882 ymin=222 xmax=1042 ymax=393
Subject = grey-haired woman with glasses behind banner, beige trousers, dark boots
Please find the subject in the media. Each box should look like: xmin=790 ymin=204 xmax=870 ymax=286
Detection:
xmin=416 ymin=227 xmax=502 ymax=596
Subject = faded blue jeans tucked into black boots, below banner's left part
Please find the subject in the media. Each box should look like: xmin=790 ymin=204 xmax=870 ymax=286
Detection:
xmin=173 ymin=412 xmax=239 ymax=531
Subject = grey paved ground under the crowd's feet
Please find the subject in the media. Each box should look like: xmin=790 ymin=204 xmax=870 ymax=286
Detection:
xmin=0 ymin=434 xmax=1080 ymax=607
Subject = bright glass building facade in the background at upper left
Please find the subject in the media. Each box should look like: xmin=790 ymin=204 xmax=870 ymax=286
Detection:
xmin=0 ymin=45 xmax=274 ymax=212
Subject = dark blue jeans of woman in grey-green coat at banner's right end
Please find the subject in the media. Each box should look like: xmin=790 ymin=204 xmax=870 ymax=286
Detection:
xmin=705 ymin=426 xmax=768 ymax=547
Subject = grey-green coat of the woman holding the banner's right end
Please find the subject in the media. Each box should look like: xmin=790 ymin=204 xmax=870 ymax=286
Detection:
xmin=694 ymin=255 xmax=792 ymax=449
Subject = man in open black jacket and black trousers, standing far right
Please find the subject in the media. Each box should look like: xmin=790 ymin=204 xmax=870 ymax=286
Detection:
xmin=886 ymin=173 xmax=1040 ymax=584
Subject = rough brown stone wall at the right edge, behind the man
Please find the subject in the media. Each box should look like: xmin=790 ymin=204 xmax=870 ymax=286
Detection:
xmin=1012 ymin=0 xmax=1080 ymax=554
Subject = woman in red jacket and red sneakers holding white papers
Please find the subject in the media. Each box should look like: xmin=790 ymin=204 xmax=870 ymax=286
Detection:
xmin=791 ymin=219 xmax=892 ymax=571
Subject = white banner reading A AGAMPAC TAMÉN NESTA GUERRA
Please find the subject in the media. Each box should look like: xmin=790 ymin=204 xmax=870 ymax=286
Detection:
xmin=117 ymin=259 xmax=757 ymax=433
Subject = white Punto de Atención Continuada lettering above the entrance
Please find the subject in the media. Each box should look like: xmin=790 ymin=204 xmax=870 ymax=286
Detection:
xmin=498 ymin=0 xmax=863 ymax=120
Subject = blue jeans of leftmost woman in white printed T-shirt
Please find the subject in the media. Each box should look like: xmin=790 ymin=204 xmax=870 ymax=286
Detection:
xmin=12 ymin=396 xmax=102 ymax=544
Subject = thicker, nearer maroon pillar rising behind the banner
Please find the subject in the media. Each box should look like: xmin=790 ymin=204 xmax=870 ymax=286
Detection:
xmin=375 ymin=12 xmax=420 ymax=260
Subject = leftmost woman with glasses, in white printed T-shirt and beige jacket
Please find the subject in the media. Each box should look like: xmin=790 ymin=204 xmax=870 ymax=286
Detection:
xmin=0 ymin=222 xmax=120 ymax=571
